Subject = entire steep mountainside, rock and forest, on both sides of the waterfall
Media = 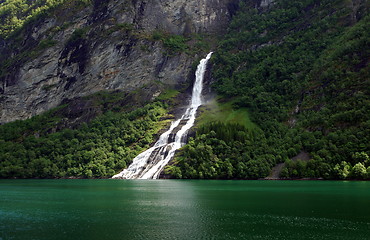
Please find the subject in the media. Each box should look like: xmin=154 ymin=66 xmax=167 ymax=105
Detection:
xmin=0 ymin=0 xmax=370 ymax=179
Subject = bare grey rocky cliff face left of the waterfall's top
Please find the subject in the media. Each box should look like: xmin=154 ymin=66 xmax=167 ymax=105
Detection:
xmin=0 ymin=0 xmax=238 ymax=123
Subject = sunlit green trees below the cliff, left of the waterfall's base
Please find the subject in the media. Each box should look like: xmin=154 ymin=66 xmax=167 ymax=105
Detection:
xmin=0 ymin=93 xmax=167 ymax=178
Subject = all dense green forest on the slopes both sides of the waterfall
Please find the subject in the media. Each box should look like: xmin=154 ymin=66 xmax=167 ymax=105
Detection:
xmin=0 ymin=0 xmax=370 ymax=179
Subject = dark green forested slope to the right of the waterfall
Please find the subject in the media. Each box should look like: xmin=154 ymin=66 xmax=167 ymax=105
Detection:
xmin=167 ymin=0 xmax=370 ymax=179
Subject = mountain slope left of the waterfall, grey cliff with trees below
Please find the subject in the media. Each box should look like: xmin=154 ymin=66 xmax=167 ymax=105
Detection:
xmin=0 ymin=0 xmax=236 ymax=178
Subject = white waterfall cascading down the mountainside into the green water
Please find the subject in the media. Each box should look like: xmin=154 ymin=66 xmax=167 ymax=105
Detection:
xmin=112 ymin=52 xmax=212 ymax=179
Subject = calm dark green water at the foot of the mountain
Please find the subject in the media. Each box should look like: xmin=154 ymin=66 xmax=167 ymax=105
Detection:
xmin=0 ymin=180 xmax=370 ymax=240
